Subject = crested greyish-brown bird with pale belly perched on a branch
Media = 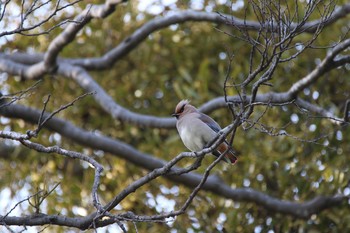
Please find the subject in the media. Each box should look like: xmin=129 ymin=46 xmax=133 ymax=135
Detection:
xmin=172 ymin=100 xmax=237 ymax=164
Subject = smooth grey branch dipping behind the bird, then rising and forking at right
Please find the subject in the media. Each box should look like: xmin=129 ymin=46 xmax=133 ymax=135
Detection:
xmin=0 ymin=49 xmax=350 ymax=128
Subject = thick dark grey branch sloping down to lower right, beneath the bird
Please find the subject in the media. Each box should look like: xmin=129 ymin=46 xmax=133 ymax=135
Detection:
xmin=0 ymin=104 xmax=347 ymax=220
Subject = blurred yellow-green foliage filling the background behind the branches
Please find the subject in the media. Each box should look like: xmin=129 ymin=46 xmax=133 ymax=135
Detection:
xmin=0 ymin=1 xmax=350 ymax=233
